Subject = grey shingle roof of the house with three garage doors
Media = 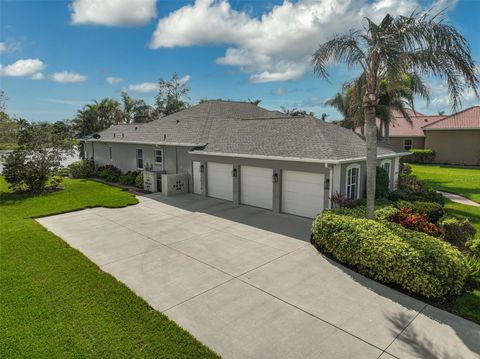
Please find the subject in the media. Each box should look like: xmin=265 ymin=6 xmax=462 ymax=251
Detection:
xmin=89 ymin=100 xmax=404 ymax=161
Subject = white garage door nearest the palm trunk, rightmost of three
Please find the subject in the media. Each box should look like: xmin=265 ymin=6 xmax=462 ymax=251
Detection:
xmin=282 ymin=171 xmax=324 ymax=218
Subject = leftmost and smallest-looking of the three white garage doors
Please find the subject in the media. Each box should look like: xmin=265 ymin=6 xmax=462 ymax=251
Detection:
xmin=207 ymin=162 xmax=233 ymax=201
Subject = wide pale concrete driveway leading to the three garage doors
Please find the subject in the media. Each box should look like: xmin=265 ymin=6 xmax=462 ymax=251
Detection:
xmin=38 ymin=194 xmax=480 ymax=359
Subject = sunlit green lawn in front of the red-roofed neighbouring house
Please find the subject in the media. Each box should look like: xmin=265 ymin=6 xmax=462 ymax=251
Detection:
xmin=409 ymin=164 xmax=480 ymax=203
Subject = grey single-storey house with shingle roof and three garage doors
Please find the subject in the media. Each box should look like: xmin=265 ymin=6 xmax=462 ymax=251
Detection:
xmin=85 ymin=101 xmax=405 ymax=217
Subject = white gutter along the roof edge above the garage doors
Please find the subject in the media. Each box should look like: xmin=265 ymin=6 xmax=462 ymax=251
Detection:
xmin=188 ymin=151 xmax=411 ymax=164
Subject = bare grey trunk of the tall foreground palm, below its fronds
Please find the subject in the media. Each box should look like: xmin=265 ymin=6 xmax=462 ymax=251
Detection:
xmin=363 ymin=95 xmax=377 ymax=219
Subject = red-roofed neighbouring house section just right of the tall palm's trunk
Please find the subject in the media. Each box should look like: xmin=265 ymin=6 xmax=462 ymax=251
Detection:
xmin=389 ymin=109 xmax=445 ymax=151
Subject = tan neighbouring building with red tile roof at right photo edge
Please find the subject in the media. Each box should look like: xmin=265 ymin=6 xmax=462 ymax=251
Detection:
xmin=422 ymin=106 xmax=480 ymax=166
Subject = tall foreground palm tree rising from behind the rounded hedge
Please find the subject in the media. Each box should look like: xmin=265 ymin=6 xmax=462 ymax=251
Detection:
xmin=312 ymin=11 xmax=479 ymax=218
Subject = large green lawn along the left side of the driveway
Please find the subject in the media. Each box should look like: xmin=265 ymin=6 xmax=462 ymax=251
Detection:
xmin=0 ymin=177 xmax=216 ymax=358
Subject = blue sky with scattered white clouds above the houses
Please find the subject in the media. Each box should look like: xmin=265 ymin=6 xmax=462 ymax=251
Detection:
xmin=0 ymin=0 xmax=480 ymax=121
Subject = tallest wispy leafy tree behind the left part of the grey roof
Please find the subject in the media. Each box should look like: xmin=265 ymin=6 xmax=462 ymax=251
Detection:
xmin=155 ymin=73 xmax=190 ymax=116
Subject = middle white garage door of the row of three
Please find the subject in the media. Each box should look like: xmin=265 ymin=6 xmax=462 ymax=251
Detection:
xmin=240 ymin=166 xmax=273 ymax=209
